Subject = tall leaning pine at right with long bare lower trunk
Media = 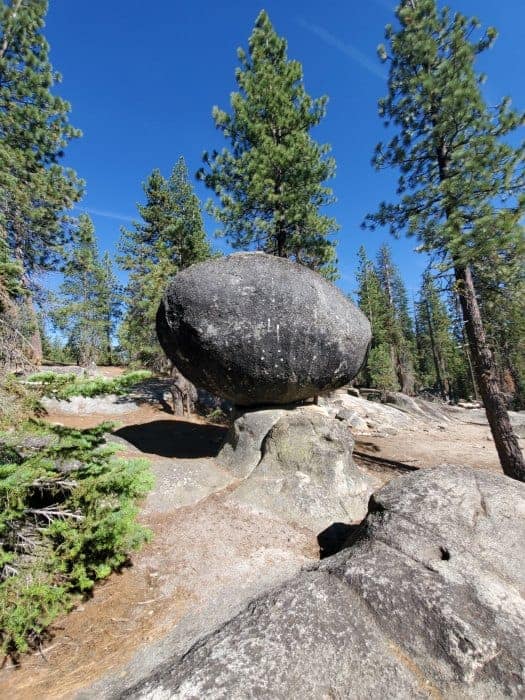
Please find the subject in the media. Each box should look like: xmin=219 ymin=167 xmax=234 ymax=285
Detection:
xmin=368 ymin=0 xmax=525 ymax=480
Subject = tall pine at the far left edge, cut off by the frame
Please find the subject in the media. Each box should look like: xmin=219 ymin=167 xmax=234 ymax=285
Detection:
xmin=0 ymin=0 xmax=81 ymax=355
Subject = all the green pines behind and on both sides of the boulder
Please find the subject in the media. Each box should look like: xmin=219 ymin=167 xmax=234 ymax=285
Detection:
xmin=0 ymin=0 xmax=525 ymax=478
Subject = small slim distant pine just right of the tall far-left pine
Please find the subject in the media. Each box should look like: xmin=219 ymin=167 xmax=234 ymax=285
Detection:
xmin=53 ymin=214 xmax=106 ymax=366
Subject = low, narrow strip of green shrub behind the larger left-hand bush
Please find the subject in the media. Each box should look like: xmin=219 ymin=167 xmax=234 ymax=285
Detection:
xmin=26 ymin=370 xmax=152 ymax=400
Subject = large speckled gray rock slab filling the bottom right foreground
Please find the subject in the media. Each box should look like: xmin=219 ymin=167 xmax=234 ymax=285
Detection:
xmin=125 ymin=467 xmax=525 ymax=700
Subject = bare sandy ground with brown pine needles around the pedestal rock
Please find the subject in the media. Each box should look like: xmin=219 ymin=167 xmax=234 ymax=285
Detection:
xmin=0 ymin=380 xmax=523 ymax=700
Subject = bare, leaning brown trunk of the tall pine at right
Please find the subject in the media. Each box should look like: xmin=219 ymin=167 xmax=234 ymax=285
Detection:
xmin=454 ymin=266 xmax=525 ymax=481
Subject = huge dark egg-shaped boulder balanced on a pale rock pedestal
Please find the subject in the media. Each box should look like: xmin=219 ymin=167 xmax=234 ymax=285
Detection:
xmin=157 ymin=253 xmax=371 ymax=406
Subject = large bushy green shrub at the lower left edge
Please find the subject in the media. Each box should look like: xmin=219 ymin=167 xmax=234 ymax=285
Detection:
xmin=0 ymin=421 xmax=152 ymax=658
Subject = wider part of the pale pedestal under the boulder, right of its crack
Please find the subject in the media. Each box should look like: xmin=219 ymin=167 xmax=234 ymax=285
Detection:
xmin=230 ymin=406 xmax=372 ymax=533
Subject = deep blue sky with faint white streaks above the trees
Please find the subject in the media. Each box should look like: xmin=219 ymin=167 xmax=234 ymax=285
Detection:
xmin=45 ymin=0 xmax=525 ymax=294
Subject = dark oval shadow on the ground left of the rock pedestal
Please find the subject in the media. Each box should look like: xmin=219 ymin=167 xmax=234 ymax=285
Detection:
xmin=114 ymin=420 xmax=227 ymax=459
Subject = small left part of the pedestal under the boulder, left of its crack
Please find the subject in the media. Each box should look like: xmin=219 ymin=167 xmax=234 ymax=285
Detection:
xmin=217 ymin=408 xmax=285 ymax=479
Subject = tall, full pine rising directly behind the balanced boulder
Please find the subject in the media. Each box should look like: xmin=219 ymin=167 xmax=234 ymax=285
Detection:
xmin=198 ymin=11 xmax=338 ymax=279
